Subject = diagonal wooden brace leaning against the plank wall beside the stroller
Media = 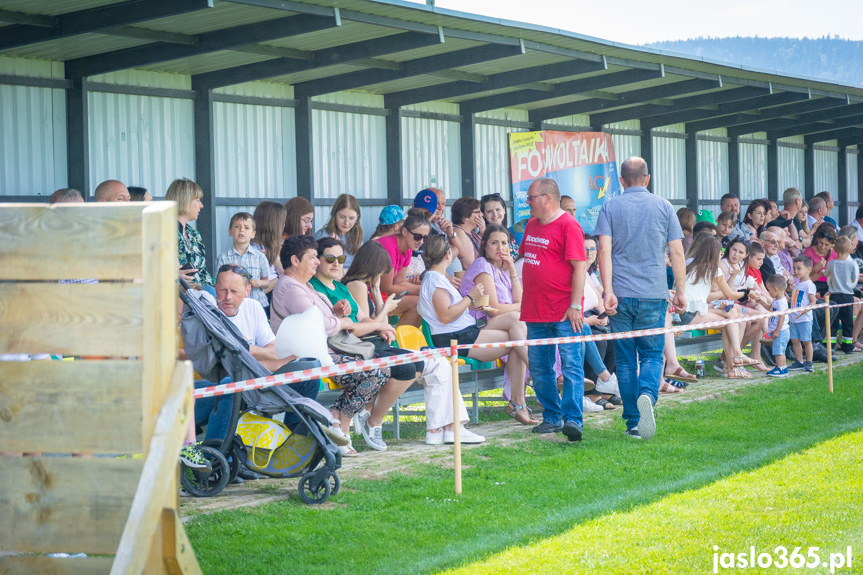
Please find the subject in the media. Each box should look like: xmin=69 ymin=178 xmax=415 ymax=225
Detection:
xmin=111 ymin=362 xmax=194 ymax=575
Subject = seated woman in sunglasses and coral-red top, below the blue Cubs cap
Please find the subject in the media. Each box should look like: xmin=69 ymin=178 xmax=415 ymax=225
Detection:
xmin=374 ymin=214 xmax=431 ymax=326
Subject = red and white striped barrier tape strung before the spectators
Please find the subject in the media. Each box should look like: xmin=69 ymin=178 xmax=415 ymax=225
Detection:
xmin=194 ymin=302 xmax=854 ymax=399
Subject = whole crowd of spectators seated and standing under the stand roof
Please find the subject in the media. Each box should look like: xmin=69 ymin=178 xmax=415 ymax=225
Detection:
xmin=27 ymin=169 xmax=863 ymax=464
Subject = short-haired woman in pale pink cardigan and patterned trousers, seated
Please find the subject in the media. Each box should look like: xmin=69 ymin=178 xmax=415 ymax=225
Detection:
xmin=270 ymin=235 xmax=414 ymax=457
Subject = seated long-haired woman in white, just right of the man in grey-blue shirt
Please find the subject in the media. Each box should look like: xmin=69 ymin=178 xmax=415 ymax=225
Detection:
xmin=677 ymin=232 xmax=758 ymax=379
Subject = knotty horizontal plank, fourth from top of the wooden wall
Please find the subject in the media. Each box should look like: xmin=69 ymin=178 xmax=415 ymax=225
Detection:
xmin=0 ymin=456 xmax=143 ymax=554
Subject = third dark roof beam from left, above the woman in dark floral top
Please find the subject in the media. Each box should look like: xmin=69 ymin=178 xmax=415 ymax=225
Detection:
xmin=192 ymin=32 xmax=440 ymax=89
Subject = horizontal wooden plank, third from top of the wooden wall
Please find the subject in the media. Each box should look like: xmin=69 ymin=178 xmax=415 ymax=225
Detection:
xmin=0 ymin=360 xmax=143 ymax=453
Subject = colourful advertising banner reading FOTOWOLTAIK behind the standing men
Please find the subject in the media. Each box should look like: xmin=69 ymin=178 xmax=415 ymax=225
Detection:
xmin=509 ymin=130 xmax=620 ymax=233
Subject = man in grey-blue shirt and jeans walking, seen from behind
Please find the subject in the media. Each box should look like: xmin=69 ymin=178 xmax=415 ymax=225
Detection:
xmin=593 ymin=157 xmax=686 ymax=439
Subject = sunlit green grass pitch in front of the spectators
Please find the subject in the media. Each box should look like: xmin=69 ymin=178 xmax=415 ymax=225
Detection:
xmin=187 ymin=365 xmax=863 ymax=574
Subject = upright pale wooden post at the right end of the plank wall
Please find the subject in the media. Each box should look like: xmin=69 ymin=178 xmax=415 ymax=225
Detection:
xmin=141 ymin=203 xmax=180 ymax=455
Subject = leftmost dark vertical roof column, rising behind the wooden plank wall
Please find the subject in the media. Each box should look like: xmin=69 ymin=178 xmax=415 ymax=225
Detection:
xmin=66 ymin=76 xmax=92 ymax=200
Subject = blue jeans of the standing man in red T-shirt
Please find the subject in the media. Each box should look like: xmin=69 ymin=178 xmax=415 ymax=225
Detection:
xmin=527 ymin=321 xmax=590 ymax=427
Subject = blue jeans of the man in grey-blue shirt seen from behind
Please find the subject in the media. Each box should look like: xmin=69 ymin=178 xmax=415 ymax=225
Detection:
xmin=609 ymin=297 xmax=668 ymax=429
